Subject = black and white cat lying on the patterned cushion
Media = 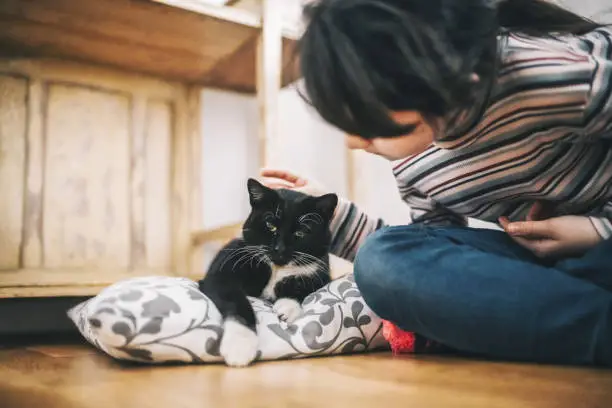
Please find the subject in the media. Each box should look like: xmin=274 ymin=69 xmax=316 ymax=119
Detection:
xmin=199 ymin=179 xmax=338 ymax=367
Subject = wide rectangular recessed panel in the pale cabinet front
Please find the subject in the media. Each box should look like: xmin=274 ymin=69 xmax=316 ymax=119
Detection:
xmin=43 ymin=84 xmax=130 ymax=268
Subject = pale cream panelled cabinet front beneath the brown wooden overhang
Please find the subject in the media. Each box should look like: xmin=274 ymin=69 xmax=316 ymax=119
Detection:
xmin=0 ymin=60 xmax=199 ymax=297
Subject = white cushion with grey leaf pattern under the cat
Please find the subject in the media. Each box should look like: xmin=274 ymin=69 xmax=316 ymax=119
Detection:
xmin=68 ymin=275 xmax=388 ymax=363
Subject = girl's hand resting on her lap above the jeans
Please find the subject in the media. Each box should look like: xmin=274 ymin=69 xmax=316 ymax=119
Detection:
xmin=499 ymin=203 xmax=602 ymax=258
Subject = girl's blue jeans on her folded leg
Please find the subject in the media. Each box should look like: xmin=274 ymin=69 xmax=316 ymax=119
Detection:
xmin=355 ymin=225 xmax=612 ymax=366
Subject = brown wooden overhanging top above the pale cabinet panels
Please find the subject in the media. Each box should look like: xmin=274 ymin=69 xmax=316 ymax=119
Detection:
xmin=0 ymin=0 xmax=299 ymax=92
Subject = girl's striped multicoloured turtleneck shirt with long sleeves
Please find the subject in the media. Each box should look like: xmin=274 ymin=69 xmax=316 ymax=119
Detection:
xmin=331 ymin=29 xmax=612 ymax=260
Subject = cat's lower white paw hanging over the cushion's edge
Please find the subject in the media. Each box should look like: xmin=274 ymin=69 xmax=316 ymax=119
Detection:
xmin=219 ymin=318 xmax=258 ymax=367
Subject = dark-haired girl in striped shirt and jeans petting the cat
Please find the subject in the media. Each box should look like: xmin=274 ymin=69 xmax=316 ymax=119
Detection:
xmin=263 ymin=0 xmax=612 ymax=366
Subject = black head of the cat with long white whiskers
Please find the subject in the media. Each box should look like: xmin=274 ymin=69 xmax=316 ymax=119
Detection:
xmin=243 ymin=179 xmax=338 ymax=266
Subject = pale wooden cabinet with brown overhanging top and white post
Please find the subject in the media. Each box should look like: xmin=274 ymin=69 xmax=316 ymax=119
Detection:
xmin=0 ymin=0 xmax=297 ymax=297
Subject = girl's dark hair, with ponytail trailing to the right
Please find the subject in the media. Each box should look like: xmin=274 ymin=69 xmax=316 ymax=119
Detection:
xmin=298 ymin=0 xmax=602 ymax=137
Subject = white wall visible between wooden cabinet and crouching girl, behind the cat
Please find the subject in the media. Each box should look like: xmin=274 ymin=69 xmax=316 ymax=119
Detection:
xmin=202 ymin=88 xmax=492 ymax=239
